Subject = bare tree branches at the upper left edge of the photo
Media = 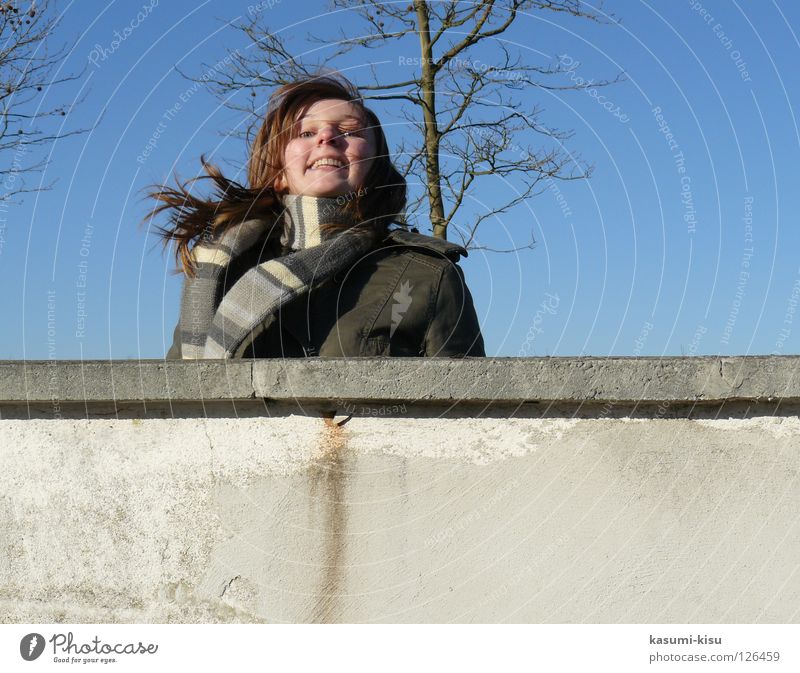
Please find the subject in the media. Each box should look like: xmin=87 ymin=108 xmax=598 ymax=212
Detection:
xmin=0 ymin=0 xmax=85 ymax=202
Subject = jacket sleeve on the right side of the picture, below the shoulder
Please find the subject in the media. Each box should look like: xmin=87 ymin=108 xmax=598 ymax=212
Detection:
xmin=424 ymin=264 xmax=486 ymax=357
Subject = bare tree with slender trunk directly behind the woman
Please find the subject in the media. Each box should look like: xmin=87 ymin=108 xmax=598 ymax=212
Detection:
xmin=191 ymin=0 xmax=621 ymax=247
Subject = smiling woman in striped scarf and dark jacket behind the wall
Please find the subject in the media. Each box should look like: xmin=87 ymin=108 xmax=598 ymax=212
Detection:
xmin=151 ymin=76 xmax=484 ymax=359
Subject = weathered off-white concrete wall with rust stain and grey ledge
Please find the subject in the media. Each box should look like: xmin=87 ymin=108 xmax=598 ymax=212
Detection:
xmin=0 ymin=357 xmax=800 ymax=623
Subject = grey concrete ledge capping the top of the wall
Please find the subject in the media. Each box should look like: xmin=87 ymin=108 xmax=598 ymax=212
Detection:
xmin=0 ymin=356 xmax=800 ymax=404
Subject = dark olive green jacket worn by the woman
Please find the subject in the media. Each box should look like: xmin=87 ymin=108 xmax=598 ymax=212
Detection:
xmin=167 ymin=229 xmax=485 ymax=358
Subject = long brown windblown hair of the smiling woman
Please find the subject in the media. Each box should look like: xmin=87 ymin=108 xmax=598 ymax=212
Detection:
xmin=148 ymin=73 xmax=406 ymax=275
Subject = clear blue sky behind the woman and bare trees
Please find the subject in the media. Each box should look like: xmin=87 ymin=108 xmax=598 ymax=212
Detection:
xmin=0 ymin=0 xmax=800 ymax=359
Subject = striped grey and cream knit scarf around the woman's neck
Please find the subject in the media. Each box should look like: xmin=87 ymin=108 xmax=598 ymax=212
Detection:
xmin=180 ymin=195 xmax=372 ymax=360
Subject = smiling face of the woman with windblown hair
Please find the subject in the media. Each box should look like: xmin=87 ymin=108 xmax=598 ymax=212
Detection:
xmin=275 ymin=98 xmax=376 ymax=197
